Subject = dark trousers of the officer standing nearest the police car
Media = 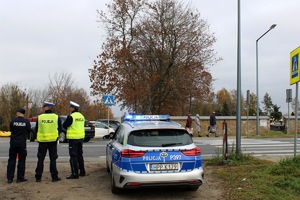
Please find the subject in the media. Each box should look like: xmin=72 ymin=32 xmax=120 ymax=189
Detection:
xmin=69 ymin=139 xmax=85 ymax=176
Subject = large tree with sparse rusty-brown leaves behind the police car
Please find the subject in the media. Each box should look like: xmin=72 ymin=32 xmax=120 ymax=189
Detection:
xmin=89 ymin=0 xmax=219 ymax=115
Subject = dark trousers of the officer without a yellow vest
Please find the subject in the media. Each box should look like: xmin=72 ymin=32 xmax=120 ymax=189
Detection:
xmin=7 ymin=143 xmax=27 ymax=180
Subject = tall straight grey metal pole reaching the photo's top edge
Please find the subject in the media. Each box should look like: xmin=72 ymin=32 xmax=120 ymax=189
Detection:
xmin=236 ymin=0 xmax=241 ymax=155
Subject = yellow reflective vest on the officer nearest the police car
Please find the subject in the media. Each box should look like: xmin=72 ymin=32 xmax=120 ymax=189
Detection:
xmin=67 ymin=112 xmax=85 ymax=139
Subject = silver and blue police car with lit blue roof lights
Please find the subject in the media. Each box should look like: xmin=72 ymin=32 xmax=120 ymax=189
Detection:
xmin=106 ymin=115 xmax=204 ymax=194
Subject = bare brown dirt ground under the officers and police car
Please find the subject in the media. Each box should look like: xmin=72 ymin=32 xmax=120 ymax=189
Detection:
xmin=0 ymin=159 xmax=224 ymax=200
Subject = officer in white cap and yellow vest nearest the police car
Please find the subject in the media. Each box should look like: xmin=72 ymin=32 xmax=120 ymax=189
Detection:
xmin=63 ymin=101 xmax=85 ymax=179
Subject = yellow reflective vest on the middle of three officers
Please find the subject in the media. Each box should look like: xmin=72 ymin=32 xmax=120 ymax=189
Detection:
xmin=37 ymin=113 xmax=58 ymax=142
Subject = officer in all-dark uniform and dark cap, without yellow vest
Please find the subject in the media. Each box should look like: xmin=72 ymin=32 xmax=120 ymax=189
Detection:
xmin=7 ymin=108 xmax=31 ymax=183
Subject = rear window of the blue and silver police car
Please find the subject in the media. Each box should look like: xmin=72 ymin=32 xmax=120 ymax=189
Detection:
xmin=127 ymin=129 xmax=193 ymax=147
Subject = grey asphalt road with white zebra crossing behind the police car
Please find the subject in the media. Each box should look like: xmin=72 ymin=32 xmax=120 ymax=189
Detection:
xmin=0 ymin=137 xmax=300 ymax=161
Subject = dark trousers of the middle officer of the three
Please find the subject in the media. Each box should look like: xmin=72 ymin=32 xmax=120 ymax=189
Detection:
xmin=35 ymin=142 xmax=58 ymax=179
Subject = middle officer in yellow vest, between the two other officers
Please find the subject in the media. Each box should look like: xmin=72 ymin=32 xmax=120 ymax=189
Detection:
xmin=35 ymin=101 xmax=62 ymax=182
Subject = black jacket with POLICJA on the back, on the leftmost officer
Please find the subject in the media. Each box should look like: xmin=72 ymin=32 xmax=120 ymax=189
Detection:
xmin=9 ymin=117 xmax=31 ymax=144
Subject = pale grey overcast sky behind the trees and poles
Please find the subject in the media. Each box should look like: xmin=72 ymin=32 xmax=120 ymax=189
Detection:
xmin=0 ymin=0 xmax=300 ymax=117
